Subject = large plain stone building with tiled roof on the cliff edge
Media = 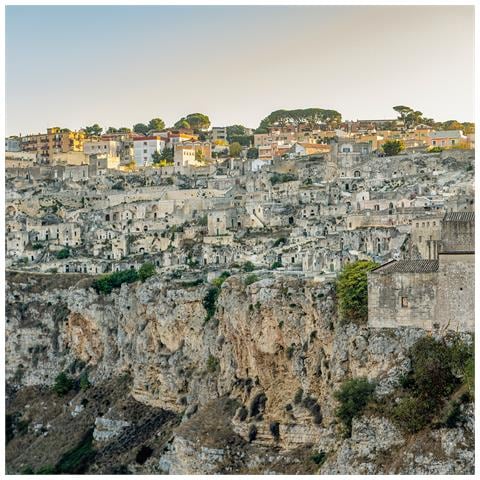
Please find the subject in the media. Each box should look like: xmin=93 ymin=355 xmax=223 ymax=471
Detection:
xmin=368 ymin=212 xmax=475 ymax=331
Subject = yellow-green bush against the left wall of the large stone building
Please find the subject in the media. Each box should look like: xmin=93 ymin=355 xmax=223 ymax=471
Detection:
xmin=336 ymin=260 xmax=378 ymax=322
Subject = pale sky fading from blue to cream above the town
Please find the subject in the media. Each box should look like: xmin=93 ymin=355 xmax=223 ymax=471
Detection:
xmin=6 ymin=6 xmax=474 ymax=135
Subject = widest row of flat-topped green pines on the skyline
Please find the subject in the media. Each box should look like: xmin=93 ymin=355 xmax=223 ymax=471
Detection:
xmin=255 ymin=108 xmax=342 ymax=133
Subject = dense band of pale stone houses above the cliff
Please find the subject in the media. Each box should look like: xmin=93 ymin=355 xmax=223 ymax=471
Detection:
xmin=6 ymin=118 xmax=474 ymax=306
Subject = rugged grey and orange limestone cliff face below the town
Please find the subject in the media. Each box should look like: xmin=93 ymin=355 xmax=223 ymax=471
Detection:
xmin=6 ymin=274 xmax=473 ymax=474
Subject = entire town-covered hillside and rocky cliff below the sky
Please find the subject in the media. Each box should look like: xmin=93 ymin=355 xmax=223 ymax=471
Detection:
xmin=5 ymin=106 xmax=475 ymax=475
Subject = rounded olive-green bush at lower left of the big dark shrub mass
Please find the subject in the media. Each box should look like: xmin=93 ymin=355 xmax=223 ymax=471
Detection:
xmin=392 ymin=396 xmax=434 ymax=433
